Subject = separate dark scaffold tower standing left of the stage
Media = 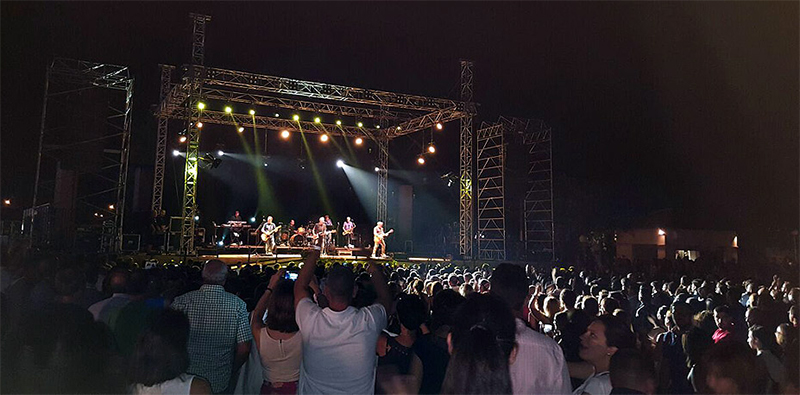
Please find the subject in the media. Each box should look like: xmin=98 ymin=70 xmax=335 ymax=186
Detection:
xmin=30 ymin=58 xmax=133 ymax=252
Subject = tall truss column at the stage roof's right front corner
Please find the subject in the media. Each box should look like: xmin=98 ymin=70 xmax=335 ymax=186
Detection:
xmin=458 ymin=60 xmax=474 ymax=259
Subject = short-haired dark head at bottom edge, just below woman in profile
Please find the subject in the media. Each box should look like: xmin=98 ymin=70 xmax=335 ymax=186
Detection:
xmin=609 ymin=349 xmax=656 ymax=394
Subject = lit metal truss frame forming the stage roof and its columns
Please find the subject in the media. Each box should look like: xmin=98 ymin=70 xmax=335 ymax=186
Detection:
xmin=153 ymin=14 xmax=474 ymax=257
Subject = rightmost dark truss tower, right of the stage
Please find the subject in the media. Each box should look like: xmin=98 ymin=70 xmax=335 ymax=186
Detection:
xmin=524 ymin=121 xmax=555 ymax=262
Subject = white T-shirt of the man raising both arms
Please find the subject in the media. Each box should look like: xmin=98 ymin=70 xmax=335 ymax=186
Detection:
xmin=295 ymin=298 xmax=386 ymax=394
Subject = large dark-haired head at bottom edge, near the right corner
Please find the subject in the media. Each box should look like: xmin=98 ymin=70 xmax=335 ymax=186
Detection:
xmin=704 ymin=342 xmax=766 ymax=394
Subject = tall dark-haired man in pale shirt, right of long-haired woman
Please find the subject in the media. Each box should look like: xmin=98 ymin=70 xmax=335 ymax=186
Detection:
xmin=489 ymin=263 xmax=572 ymax=395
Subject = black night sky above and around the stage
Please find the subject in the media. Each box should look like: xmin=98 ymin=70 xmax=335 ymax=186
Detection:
xmin=0 ymin=1 xmax=799 ymax=248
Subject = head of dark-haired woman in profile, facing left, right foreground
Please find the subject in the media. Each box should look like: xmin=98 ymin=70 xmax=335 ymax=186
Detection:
xmin=578 ymin=314 xmax=636 ymax=369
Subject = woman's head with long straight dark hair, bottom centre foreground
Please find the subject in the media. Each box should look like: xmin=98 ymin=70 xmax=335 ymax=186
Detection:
xmin=442 ymin=293 xmax=516 ymax=394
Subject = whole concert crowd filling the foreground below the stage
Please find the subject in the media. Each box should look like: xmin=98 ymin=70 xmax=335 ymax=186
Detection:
xmin=0 ymin=238 xmax=800 ymax=395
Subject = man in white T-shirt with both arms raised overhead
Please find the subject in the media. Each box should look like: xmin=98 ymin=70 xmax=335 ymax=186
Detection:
xmin=294 ymin=251 xmax=392 ymax=394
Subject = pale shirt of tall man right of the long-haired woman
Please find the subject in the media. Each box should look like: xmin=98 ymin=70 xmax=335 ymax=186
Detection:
xmin=509 ymin=318 xmax=572 ymax=395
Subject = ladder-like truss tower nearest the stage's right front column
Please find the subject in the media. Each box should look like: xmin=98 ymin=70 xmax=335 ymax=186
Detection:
xmin=477 ymin=124 xmax=506 ymax=260
